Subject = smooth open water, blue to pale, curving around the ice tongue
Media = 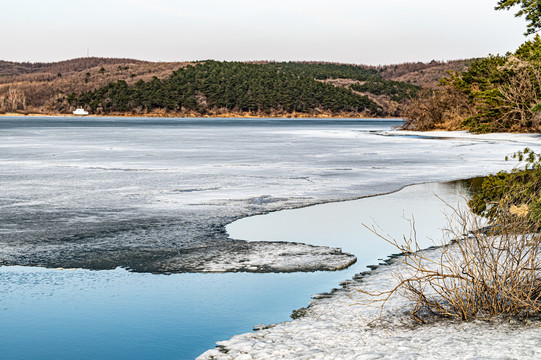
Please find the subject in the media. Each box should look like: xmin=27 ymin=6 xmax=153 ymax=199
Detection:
xmin=0 ymin=184 xmax=459 ymax=359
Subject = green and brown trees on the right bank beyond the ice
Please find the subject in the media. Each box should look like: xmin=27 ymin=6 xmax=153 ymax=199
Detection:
xmin=405 ymin=35 xmax=541 ymax=133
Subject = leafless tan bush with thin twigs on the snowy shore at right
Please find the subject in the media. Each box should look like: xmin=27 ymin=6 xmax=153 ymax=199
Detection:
xmin=359 ymin=202 xmax=541 ymax=322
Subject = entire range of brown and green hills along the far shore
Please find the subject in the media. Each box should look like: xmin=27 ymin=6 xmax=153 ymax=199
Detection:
xmin=0 ymin=58 xmax=468 ymax=116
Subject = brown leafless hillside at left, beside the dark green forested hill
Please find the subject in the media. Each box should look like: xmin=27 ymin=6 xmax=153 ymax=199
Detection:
xmin=0 ymin=58 xmax=193 ymax=114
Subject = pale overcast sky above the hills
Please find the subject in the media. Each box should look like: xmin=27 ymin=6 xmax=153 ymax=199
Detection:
xmin=0 ymin=0 xmax=526 ymax=65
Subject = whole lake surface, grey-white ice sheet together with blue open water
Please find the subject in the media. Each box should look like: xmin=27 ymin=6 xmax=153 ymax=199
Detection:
xmin=0 ymin=117 xmax=540 ymax=359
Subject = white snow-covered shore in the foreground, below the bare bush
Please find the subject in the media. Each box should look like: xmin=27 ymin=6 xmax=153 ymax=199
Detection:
xmin=197 ymin=249 xmax=541 ymax=360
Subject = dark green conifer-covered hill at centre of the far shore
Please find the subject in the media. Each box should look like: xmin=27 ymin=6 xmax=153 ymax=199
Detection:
xmin=74 ymin=61 xmax=383 ymax=116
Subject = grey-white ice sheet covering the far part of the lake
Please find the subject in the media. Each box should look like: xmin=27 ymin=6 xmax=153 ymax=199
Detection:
xmin=0 ymin=118 xmax=541 ymax=272
